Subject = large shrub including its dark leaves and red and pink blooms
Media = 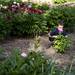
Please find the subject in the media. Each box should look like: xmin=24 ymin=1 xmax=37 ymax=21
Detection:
xmin=0 ymin=2 xmax=47 ymax=38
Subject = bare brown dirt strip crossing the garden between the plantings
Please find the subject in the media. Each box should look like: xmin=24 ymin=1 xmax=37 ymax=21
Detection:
xmin=0 ymin=34 xmax=75 ymax=65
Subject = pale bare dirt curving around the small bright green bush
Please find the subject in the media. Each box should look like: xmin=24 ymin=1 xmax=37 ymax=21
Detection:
xmin=42 ymin=34 xmax=75 ymax=65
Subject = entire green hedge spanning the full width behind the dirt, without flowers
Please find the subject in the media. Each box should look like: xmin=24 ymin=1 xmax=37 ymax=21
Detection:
xmin=0 ymin=0 xmax=75 ymax=39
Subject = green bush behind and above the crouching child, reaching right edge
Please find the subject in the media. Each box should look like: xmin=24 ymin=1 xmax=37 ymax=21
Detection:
xmin=45 ymin=7 xmax=75 ymax=31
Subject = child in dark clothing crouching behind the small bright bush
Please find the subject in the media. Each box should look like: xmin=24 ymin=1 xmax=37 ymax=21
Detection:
xmin=49 ymin=21 xmax=67 ymax=42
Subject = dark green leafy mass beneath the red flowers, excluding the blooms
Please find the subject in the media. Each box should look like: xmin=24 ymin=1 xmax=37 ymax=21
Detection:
xmin=0 ymin=10 xmax=47 ymax=39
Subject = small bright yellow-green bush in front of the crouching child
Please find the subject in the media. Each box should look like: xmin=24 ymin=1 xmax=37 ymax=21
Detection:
xmin=53 ymin=35 xmax=71 ymax=53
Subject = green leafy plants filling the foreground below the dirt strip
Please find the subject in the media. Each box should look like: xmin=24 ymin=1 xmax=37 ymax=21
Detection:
xmin=0 ymin=49 xmax=75 ymax=75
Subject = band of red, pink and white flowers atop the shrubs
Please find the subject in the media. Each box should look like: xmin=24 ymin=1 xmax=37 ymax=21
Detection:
xmin=1 ymin=2 xmax=44 ymax=14
